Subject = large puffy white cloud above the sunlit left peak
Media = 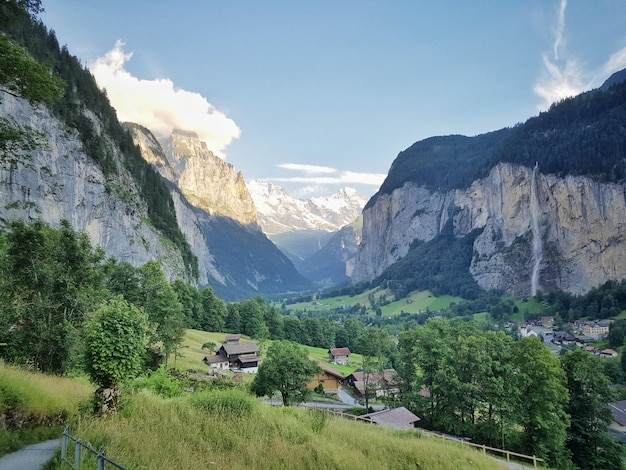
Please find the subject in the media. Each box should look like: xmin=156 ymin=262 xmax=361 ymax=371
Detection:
xmin=89 ymin=40 xmax=241 ymax=157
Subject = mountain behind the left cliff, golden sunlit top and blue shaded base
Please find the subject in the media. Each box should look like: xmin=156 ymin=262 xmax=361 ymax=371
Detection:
xmin=127 ymin=124 xmax=309 ymax=300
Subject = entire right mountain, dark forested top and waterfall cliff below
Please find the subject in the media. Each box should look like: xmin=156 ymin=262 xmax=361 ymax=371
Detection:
xmin=350 ymin=70 xmax=626 ymax=295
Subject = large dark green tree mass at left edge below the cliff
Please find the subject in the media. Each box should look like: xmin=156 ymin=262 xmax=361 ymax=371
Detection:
xmin=0 ymin=220 xmax=104 ymax=373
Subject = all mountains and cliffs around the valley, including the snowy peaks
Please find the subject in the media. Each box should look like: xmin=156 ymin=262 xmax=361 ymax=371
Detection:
xmin=0 ymin=13 xmax=626 ymax=300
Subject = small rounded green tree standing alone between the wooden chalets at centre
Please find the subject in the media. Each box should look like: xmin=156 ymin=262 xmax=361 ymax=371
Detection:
xmin=250 ymin=340 xmax=319 ymax=406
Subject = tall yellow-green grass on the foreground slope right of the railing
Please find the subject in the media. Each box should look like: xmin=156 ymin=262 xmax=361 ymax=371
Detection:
xmin=67 ymin=390 xmax=504 ymax=470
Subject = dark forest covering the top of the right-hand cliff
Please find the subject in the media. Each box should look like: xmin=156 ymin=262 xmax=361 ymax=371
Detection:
xmin=366 ymin=67 xmax=626 ymax=203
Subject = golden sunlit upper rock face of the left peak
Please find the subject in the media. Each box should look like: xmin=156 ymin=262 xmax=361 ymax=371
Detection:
xmin=163 ymin=131 xmax=257 ymax=224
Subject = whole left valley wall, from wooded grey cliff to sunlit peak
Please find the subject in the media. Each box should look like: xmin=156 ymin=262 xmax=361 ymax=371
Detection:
xmin=0 ymin=14 xmax=310 ymax=300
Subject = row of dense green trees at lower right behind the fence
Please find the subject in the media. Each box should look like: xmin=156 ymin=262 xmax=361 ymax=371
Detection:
xmin=396 ymin=318 xmax=622 ymax=469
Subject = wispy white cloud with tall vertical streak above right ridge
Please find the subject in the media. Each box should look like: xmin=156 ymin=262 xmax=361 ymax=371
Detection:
xmin=533 ymin=0 xmax=626 ymax=111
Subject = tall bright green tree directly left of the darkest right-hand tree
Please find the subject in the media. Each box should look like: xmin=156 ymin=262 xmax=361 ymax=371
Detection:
xmin=512 ymin=337 xmax=569 ymax=465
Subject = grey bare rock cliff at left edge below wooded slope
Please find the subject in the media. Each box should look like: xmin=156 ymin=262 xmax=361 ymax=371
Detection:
xmin=0 ymin=94 xmax=185 ymax=278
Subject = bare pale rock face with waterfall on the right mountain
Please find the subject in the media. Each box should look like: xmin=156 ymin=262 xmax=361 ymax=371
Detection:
xmin=350 ymin=164 xmax=626 ymax=295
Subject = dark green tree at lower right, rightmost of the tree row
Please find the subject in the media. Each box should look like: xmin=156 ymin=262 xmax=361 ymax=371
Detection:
xmin=561 ymin=348 xmax=623 ymax=470
